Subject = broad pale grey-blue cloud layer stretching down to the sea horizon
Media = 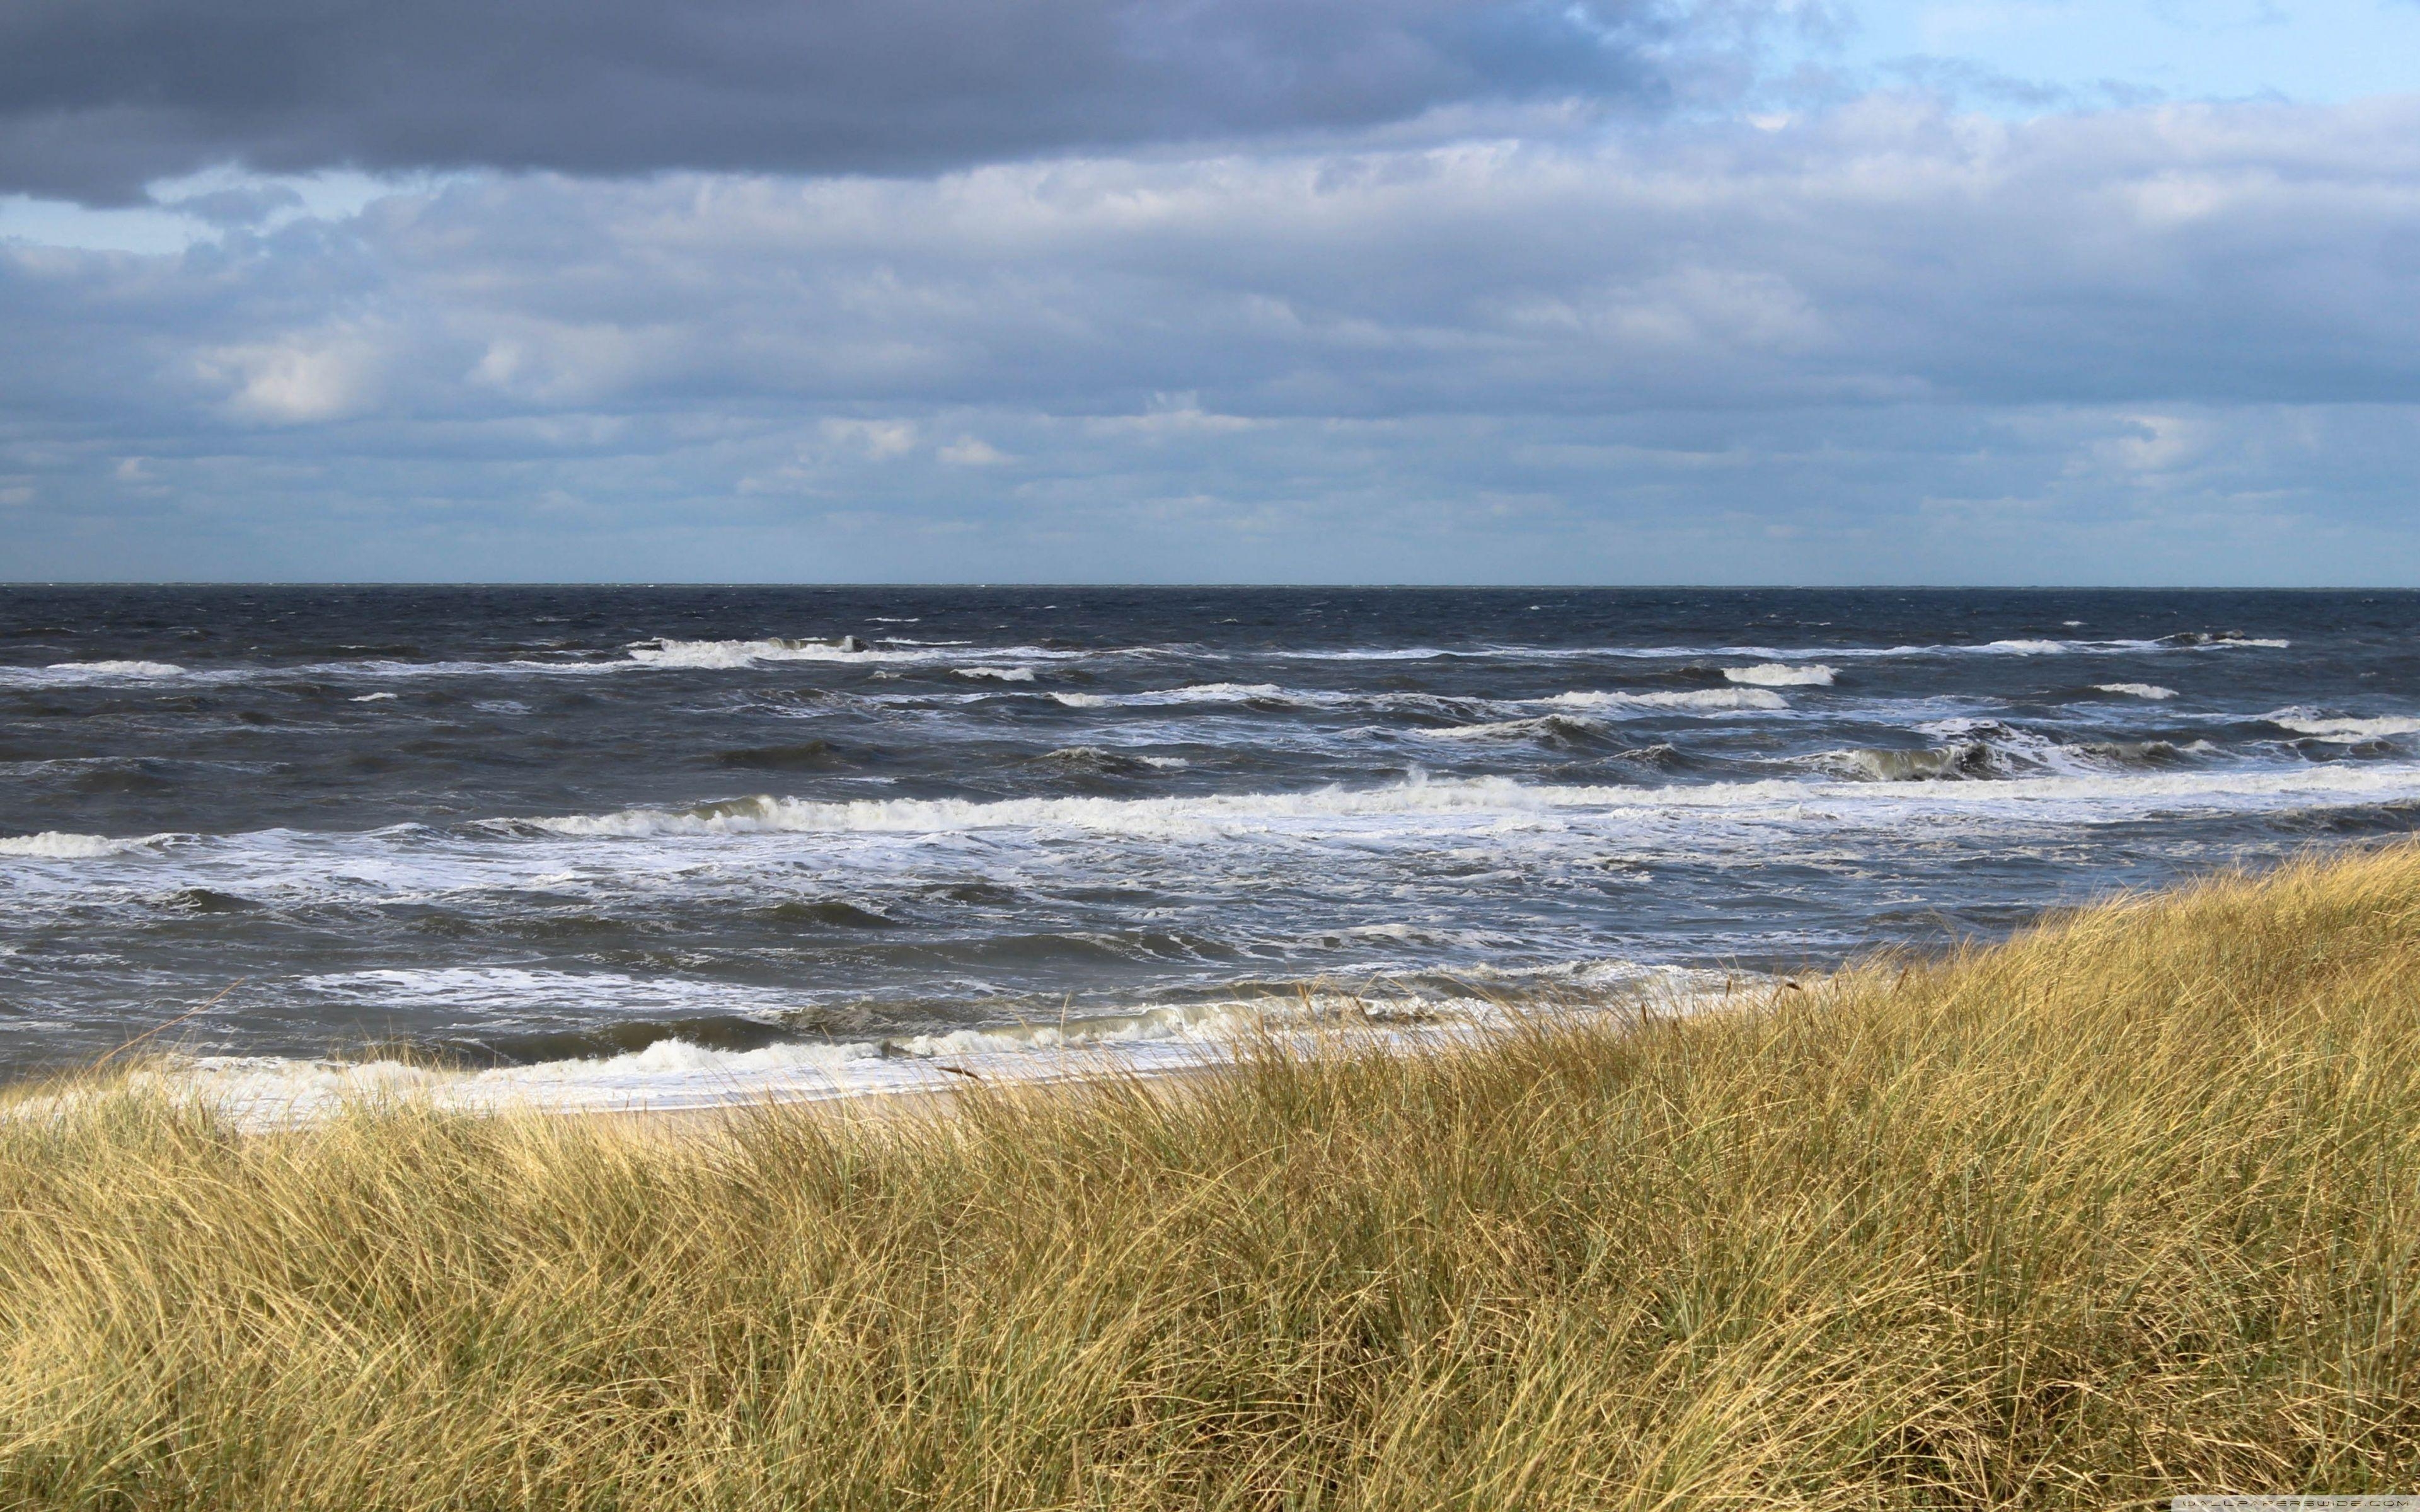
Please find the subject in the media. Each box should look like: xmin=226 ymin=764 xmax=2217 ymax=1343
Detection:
xmin=0 ymin=97 xmax=2420 ymax=581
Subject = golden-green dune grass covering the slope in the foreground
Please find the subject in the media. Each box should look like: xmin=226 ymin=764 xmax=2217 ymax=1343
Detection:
xmin=0 ymin=847 xmax=2420 ymax=1509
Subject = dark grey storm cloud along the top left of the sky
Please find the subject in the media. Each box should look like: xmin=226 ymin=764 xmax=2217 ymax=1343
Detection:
xmin=0 ymin=0 xmax=1670 ymax=203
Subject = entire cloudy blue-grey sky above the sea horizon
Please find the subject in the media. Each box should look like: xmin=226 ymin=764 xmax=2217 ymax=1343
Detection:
xmin=0 ymin=0 xmax=2420 ymax=585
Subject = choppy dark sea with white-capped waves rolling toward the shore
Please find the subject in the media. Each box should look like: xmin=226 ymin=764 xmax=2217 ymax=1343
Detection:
xmin=0 ymin=585 xmax=2420 ymax=1106
